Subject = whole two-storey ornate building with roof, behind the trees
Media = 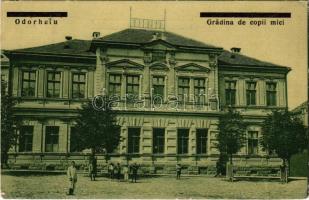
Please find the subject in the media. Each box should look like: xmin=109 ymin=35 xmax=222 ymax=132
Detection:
xmin=6 ymin=28 xmax=290 ymax=174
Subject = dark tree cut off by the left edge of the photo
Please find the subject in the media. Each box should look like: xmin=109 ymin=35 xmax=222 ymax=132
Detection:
xmin=1 ymin=81 xmax=17 ymax=167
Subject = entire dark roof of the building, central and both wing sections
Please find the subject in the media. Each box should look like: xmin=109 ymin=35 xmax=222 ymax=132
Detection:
xmin=4 ymin=29 xmax=289 ymax=70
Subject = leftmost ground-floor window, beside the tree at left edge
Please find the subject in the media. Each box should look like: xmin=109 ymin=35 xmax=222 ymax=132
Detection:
xmin=19 ymin=126 xmax=33 ymax=152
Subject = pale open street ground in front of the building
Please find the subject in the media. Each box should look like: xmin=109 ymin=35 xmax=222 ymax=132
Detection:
xmin=1 ymin=175 xmax=306 ymax=199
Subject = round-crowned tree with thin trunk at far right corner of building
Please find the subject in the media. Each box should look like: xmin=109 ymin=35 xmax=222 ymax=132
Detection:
xmin=261 ymin=110 xmax=308 ymax=181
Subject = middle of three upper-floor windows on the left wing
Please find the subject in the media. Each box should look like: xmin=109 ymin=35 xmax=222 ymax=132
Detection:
xmin=46 ymin=72 xmax=60 ymax=98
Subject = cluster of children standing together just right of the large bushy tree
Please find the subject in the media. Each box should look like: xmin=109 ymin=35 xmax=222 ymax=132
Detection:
xmin=108 ymin=163 xmax=139 ymax=183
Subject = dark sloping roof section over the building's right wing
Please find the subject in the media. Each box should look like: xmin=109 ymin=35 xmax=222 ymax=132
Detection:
xmin=218 ymin=50 xmax=286 ymax=68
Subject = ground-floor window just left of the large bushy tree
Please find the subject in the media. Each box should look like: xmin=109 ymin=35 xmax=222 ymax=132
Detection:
xmin=45 ymin=126 xmax=59 ymax=152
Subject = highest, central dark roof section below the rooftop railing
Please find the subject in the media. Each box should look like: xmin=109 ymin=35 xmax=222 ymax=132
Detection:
xmin=99 ymin=29 xmax=219 ymax=48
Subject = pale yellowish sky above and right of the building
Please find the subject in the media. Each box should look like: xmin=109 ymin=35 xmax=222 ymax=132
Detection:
xmin=1 ymin=1 xmax=308 ymax=109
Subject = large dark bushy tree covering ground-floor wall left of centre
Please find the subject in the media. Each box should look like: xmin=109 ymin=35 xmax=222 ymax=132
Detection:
xmin=72 ymin=96 xmax=120 ymax=156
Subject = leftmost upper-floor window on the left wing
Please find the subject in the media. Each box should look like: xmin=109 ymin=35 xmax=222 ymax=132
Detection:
xmin=21 ymin=71 xmax=36 ymax=97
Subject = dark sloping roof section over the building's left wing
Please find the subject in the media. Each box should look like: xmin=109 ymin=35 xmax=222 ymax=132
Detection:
xmin=13 ymin=39 xmax=95 ymax=56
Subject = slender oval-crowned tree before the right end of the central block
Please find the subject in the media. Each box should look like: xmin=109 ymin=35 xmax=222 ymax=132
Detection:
xmin=217 ymin=109 xmax=246 ymax=164
